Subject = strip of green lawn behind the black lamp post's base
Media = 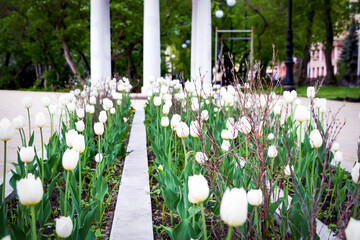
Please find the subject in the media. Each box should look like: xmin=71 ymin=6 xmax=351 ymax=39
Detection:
xmin=296 ymin=86 xmax=360 ymax=99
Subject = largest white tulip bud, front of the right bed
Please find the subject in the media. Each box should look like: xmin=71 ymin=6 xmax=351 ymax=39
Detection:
xmin=220 ymin=188 xmax=248 ymax=227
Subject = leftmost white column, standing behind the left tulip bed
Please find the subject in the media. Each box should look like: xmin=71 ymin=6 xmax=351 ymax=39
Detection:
xmin=90 ymin=0 xmax=111 ymax=84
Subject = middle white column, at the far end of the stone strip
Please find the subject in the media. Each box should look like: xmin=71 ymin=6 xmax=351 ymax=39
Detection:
xmin=141 ymin=0 xmax=161 ymax=94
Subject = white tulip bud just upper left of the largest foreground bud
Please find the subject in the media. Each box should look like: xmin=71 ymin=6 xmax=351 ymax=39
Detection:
xmin=188 ymin=174 xmax=210 ymax=203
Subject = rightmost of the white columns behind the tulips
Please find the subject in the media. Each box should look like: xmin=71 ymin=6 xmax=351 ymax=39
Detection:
xmin=191 ymin=0 xmax=212 ymax=84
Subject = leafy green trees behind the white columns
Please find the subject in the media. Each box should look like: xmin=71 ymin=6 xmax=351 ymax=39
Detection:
xmin=0 ymin=0 xmax=350 ymax=91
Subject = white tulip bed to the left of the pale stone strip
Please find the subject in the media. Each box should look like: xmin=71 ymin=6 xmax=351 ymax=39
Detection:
xmin=0 ymin=79 xmax=133 ymax=239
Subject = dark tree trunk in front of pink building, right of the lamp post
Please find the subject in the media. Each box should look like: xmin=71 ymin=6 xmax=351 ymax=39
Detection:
xmin=323 ymin=0 xmax=337 ymax=85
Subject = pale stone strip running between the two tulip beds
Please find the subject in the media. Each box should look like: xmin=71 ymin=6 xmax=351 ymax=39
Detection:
xmin=110 ymin=109 xmax=153 ymax=240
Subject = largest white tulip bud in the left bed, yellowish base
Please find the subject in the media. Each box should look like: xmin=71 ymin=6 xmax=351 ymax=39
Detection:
xmin=16 ymin=173 xmax=44 ymax=206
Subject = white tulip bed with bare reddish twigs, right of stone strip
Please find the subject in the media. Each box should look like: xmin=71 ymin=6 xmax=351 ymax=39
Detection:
xmin=146 ymin=79 xmax=360 ymax=239
